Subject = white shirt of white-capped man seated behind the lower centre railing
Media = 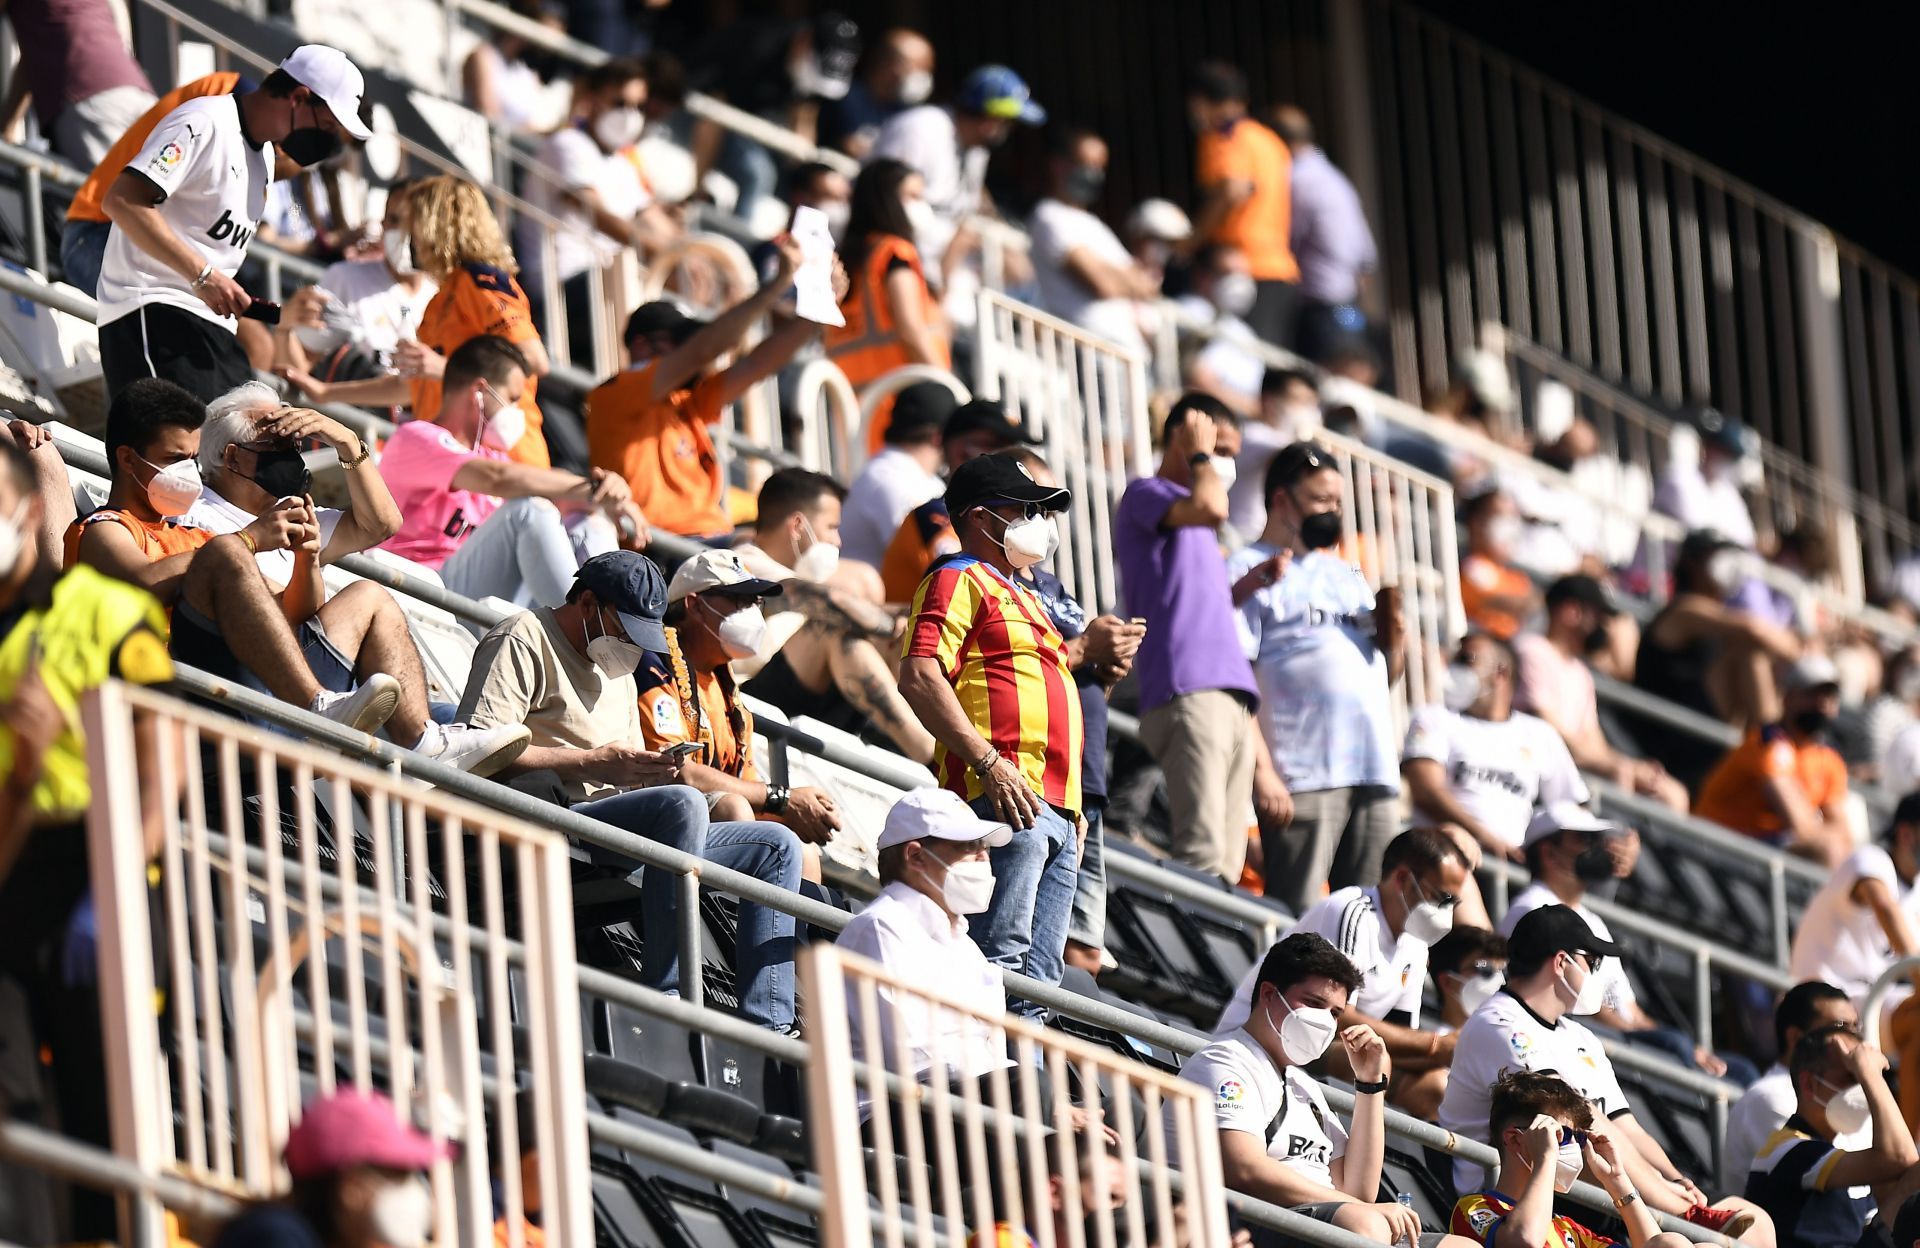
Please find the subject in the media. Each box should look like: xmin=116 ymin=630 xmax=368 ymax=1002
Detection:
xmin=833 ymin=881 xmax=1012 ymax=1119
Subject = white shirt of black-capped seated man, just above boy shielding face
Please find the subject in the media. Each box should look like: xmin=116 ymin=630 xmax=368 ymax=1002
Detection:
xmin=1440 ymin=989 xmax=1632 ymax=1192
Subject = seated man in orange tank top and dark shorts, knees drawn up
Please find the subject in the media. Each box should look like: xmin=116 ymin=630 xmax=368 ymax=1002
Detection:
xmin=67 ymin=378 xmax=526 ymax=774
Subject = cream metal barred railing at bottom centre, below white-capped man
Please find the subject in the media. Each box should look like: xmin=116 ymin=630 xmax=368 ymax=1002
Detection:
xmin=799 ymin=945 xmax=1229 ymax=1248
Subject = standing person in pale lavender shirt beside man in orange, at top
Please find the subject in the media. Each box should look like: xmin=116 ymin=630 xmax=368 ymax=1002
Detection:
xmin=1273 ymin=104 xmax=1379 ymax=363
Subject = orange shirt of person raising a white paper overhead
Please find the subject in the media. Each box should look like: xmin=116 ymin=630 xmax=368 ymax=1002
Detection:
xmin=588 ymin=363 xmax=733 ymax=538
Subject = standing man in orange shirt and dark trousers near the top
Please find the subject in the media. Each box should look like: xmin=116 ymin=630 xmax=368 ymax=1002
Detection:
xmin=1187 ymin=61 xmax=1300 ymax=348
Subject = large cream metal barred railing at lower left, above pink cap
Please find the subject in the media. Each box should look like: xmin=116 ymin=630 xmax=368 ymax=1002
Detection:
xmin=83 ymin=684 xmax=591 ymax=1244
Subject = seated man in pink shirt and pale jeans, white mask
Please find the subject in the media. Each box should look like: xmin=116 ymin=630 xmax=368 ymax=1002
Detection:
xmin=380 ymin=334 xmax=645 ymax=607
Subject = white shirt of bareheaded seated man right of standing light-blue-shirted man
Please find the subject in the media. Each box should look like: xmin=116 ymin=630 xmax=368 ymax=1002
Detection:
xmin=1400 ymin=707 xmax=1592 ymax=848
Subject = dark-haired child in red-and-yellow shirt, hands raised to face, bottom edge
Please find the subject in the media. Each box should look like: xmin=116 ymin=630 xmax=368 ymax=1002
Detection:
xmin=1452 ymin=1069 xmax=1692 ymax=1248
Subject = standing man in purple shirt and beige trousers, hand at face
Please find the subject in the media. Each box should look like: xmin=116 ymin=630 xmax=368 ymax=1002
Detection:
xmin=1114 ymin=392 xmax=1284 ymax=881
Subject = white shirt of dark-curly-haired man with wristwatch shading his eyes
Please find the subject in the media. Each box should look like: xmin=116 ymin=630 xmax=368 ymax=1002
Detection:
xmin=1165 ymin=1029 xmax=1346 ymax=1187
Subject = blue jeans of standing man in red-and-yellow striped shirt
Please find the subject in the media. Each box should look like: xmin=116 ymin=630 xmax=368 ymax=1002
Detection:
xmin=970 ymin=797 xmax=1079 ymax=1018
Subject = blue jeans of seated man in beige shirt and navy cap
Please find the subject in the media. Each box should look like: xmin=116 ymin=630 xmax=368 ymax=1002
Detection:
xmin=574 ymin=785 xmax=802 ymax=1031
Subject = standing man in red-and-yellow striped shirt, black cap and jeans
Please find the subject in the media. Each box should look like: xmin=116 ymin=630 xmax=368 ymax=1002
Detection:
xmin=900 ymin=455 xmax=1085 ymax=1016
